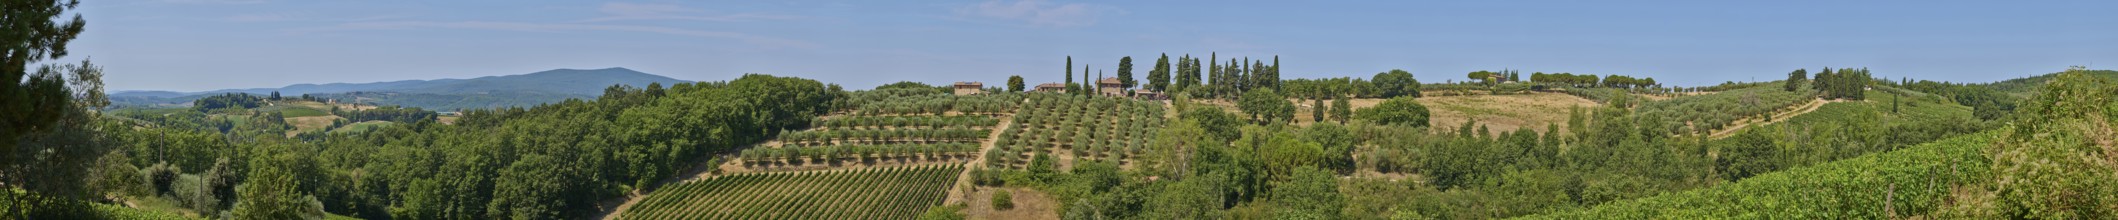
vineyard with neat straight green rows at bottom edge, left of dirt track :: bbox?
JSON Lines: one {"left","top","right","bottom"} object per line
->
{"left": 621, "top": 165, "right": 964, "bottom": 220}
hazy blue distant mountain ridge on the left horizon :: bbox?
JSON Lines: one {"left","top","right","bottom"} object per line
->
{"left": 110, "top": 68, "right": 690, "bottom": 97}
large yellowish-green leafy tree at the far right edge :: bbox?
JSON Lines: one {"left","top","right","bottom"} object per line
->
{"left": 1991, "top": 66, "right": 2118, "bottom": 220}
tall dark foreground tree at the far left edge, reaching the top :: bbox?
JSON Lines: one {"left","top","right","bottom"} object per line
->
{"left": 0, "top": 0, "right": 108, "bottom": 204}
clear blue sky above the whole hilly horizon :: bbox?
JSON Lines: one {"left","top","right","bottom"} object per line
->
{"left": 66, "top": 0, "right": 2118, "bottom": 91}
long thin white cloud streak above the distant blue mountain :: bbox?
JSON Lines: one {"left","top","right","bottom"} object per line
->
{"left": 299, "top": 21, "right": 818, "bottom": 49}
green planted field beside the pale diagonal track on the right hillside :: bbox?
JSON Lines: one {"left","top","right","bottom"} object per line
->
{"left": 1639, "top": 87, "right": 1817, "bottom": 133}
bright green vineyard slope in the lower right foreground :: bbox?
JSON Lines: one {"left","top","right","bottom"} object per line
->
{"left": 1533, "top": 131, "right": 1997, "bottom": 220}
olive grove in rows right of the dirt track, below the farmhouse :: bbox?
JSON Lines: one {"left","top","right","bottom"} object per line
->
{"left": 985, "top": 93, "right": 1165, "bottom": 167}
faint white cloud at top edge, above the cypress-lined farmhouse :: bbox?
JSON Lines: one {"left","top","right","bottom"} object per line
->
{"left": 955, "top": 0, "right": 1116, "bottom": 28}
